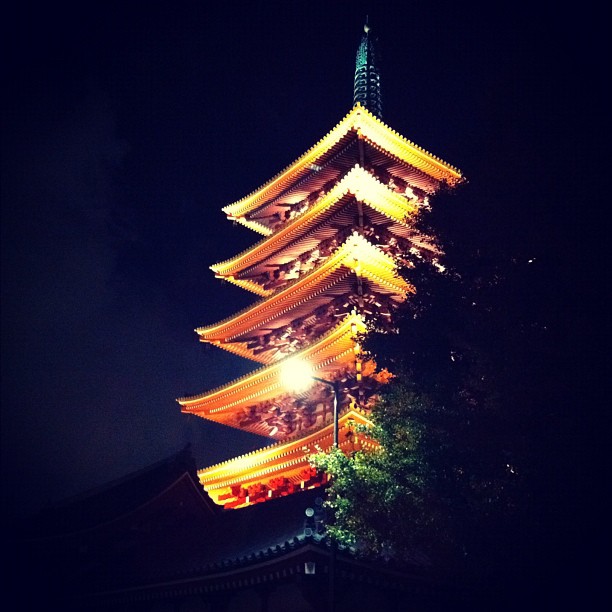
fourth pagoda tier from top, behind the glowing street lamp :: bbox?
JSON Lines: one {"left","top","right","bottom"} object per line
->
{"left": 178, "top": 314, "right": 386, "bottom": 440}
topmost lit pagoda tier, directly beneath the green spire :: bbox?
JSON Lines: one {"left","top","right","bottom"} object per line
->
{"left": 223, "top": 103, "right": 463, "bottom": 235}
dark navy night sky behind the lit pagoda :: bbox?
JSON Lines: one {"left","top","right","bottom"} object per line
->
{"left": 2, "top": 0, "right": 604, "bottom": 510}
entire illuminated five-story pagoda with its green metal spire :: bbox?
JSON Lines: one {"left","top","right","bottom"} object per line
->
{"left": 177, "top": 25, "right": 463, "bottom": 508}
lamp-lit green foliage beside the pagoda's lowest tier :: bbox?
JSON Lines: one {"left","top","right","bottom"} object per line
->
{"left": 313, "top": 389, "right": 436, "bottom": 557}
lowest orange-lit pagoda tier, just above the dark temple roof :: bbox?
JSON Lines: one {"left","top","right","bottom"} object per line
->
{"left": 198, "top": 409, "right": 373, "bottom": 509}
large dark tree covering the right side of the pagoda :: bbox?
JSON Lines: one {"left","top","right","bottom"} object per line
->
{"left": 315, "top": 185, "right": 567, "bottom": 590}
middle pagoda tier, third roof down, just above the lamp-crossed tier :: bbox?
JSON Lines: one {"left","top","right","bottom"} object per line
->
{"left": 196, "top": 233, "right": 414, "bottom": 363}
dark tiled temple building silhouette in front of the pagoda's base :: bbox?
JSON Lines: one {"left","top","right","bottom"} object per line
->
{"left": 10, "top": 448, "right": 466, "bottom": 612}
